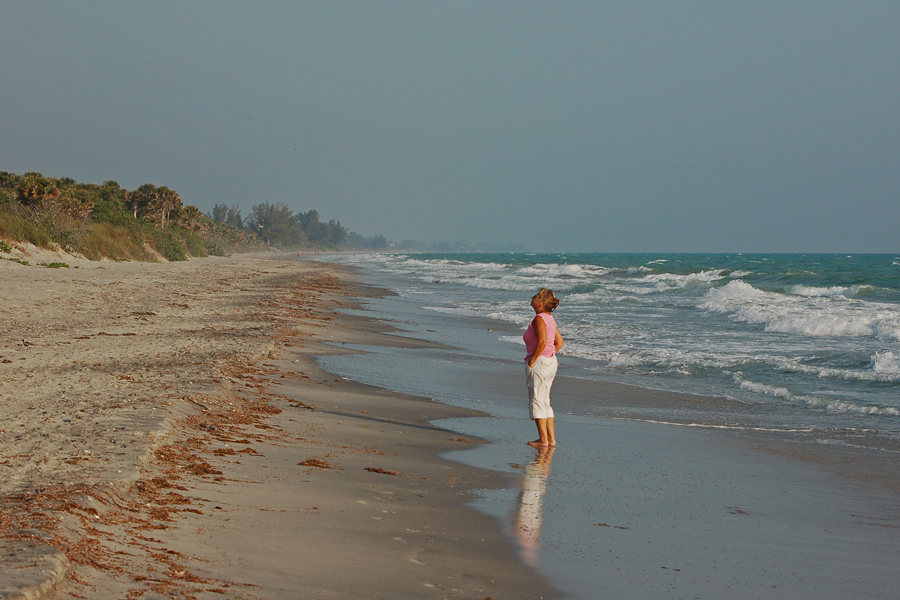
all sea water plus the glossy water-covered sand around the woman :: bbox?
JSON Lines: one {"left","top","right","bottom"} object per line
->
{"left": 320, "top": 253, "right": 900, "bottom": 600}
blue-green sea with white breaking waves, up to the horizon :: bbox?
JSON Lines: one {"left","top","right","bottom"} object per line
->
{"left": 320, "top": 254, "right": 900, "bottom": 448}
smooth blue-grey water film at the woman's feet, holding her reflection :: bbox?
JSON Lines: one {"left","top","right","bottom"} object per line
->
{"left": 440, "top": 415, "right": 900, "bottom": 600}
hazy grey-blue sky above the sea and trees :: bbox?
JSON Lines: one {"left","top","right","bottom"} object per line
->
{"left": 0, "top": 0, "right": 900, "bottom": 252}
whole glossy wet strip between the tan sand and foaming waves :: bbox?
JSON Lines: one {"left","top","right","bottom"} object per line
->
{"left": 308, "top": 268, "right": 900, "bottom": 600}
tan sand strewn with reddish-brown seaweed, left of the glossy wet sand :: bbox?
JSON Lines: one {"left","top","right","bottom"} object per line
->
{"left": 0, "top": 255, "right": 556, "bottom": 599}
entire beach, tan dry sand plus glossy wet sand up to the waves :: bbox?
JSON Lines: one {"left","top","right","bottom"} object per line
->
{"left": 7, "top": 254, "right": 900, "bottom": 600}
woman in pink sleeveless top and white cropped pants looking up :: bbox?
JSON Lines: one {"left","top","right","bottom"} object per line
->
{"left": 523, "top": 288, "right": 563, "bottom": 448}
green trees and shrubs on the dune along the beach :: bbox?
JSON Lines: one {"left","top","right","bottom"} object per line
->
{"left": 0, "top": 171, "right": 389, "bottom": 260}
